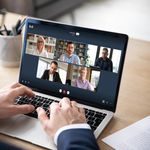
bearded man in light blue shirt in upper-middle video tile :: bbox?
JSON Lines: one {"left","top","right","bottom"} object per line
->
{"left": 60, "top": 42, "right": 80, "bottom": 65}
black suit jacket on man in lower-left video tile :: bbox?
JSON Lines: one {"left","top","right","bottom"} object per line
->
{"left": 41, "top": 70, "right": 62, "bottom": 83}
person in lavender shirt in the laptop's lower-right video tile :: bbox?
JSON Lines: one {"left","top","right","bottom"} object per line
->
{"left": 74, "top": 68, "right": 94, "bottom": 91}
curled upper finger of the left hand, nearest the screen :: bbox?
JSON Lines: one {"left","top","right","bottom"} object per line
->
{"left": 9, "top": 86, "right": 35, "bottom": 100}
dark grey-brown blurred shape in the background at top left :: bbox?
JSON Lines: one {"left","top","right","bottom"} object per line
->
{"left": 0, "top": 0, "right": 87, "bottom": 20}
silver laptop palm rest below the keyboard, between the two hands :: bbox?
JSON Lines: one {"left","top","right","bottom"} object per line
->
{"left": 0, "top": 115, "right": 56, "bottom": 149}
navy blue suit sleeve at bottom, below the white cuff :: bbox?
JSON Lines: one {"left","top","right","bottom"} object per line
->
{"left": 57, "top": 129, "right": 99, "bottom": 150}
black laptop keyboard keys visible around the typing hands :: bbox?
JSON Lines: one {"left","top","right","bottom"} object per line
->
{"left": 16, "top": 95, "right": 106, "bottom": 131}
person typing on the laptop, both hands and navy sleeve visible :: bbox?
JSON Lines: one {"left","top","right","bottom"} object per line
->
{"left": 0, "top": 83, "right": 99, "bottom": 150}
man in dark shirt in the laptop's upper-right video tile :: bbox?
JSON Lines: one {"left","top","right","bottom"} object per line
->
{"left": 95, "top": 48, "right": 113, "bottom": 72}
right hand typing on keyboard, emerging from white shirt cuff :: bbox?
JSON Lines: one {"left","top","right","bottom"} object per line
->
{"left": 37, "top": 98, "right": 86, "bottom": 138}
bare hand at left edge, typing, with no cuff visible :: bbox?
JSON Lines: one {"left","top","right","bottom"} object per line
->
{"left": 0, "top": 83, "right": 35, "bottom": 119}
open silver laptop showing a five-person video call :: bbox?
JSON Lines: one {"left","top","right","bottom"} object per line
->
{"left": 0, "top": 17, "right": 128, "bottom": 149}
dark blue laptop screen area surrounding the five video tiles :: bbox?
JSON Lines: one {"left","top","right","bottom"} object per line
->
{"left": 19, "top": 19, "right": 128, "bottom": 111}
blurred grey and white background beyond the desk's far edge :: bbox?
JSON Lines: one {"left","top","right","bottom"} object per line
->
{"left": 0, "top": 0, "right": 150, "bottom": 41}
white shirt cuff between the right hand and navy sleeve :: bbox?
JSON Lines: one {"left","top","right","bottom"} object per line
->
{"left": 54, "top": 123, "right": 91, "bottom": 145}
